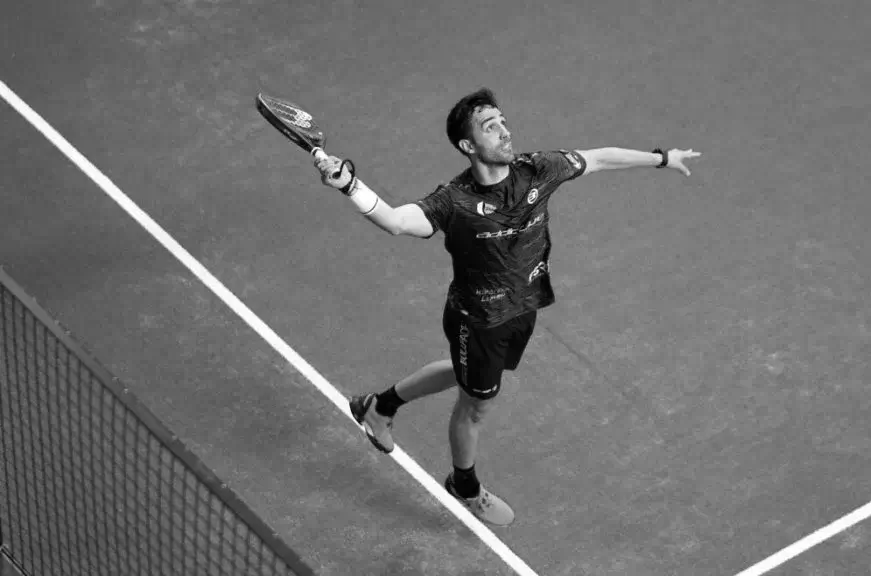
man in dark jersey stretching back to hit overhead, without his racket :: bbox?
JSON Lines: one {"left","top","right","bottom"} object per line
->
{"left": 315, "top": 89, "right": 699, "bottom": 526}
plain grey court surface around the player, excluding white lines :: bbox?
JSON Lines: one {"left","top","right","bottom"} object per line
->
{"left": 0, "top": 0, "right": 871, "bottom": 576}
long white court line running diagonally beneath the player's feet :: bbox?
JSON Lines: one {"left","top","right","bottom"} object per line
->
{"left": 0, "top": 81, "right": 537, "bottom": 576}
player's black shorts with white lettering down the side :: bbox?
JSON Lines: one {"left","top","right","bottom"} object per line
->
{"left": 442, "top": 306, "right": 537, "bottom": 400}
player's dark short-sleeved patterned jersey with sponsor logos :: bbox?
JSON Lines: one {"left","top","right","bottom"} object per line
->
{"left": 417, "top": 150, "right": 586, "bottom": 327}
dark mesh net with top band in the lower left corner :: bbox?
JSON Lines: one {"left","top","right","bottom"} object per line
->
{"left": 0, "top": 269, "right": 313, "bottom": 576}
